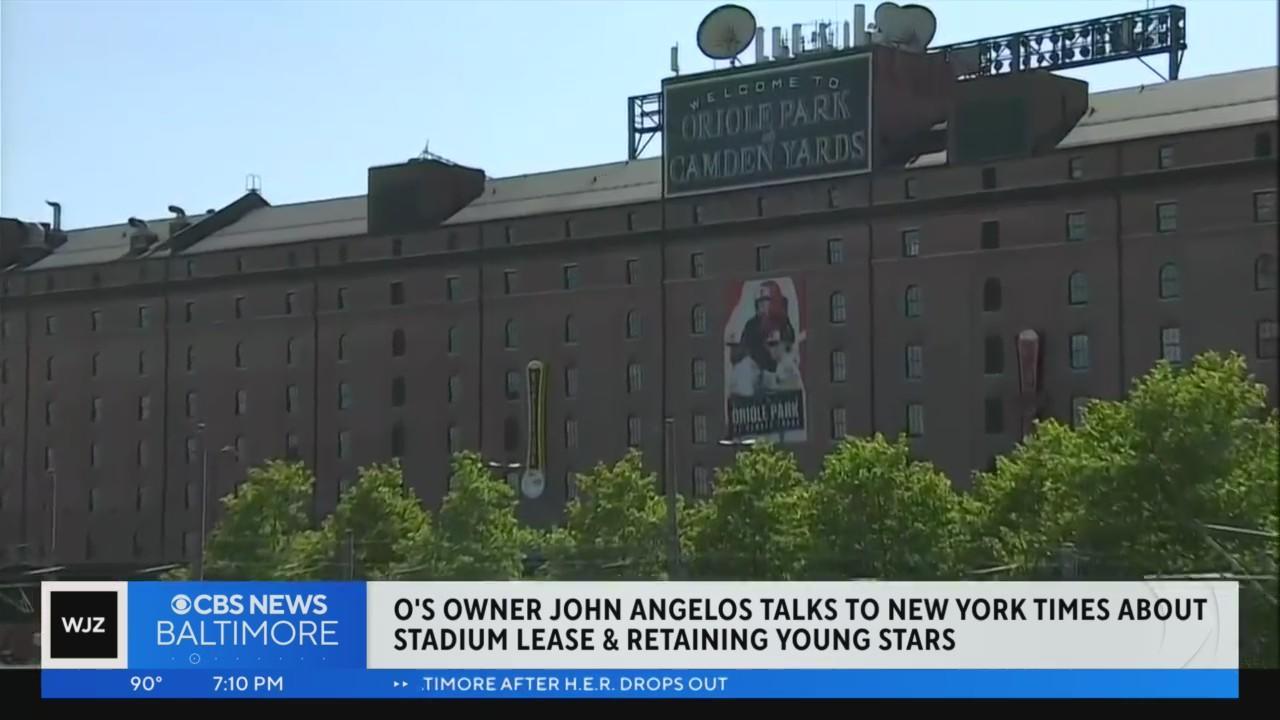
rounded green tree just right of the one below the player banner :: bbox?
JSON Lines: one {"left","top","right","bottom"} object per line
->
{"left": 806, "top": 434, "right": 964, "bottom": 579}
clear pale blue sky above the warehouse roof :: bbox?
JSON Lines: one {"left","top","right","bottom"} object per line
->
{"left": 0, "top": 0, "right": 1276, "bottom": 228}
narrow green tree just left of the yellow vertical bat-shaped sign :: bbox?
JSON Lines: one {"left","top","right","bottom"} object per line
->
{"left": 438, "top": 452, "right": 534, "bottom": 580}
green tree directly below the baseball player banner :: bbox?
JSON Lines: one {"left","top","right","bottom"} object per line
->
{"left": 684, "top": 443, "right": 810, "bottom": 580}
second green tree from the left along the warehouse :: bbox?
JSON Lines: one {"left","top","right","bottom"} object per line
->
{"left": 294, "top": 461, "right": 436, "bottom": 579}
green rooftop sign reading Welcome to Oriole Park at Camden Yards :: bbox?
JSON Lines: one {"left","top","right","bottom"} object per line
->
{"left": 662, "top": 51, "right": 872, "bottom": 196}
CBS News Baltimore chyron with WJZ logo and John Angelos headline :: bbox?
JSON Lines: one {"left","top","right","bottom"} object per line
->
{"left": 41, "top": 582, "right": 1239, "bottom": 700}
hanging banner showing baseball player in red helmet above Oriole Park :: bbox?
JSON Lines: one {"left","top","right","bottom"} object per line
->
{"left": 724, "top": 278, "right": 808, "bottom": 443}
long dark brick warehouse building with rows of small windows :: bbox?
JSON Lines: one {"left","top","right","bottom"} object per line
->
{"left": 0, "top": 49, "right": 1277, "bottom": 562}
